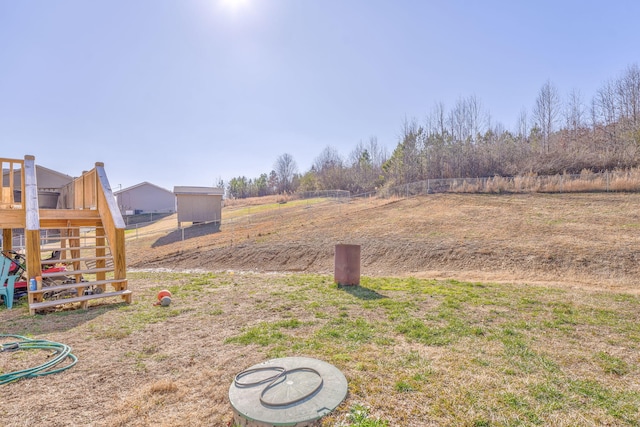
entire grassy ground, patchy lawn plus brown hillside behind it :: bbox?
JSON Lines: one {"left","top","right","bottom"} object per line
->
{"left": 0, "top": 193, "right": 640, "bottom": 427}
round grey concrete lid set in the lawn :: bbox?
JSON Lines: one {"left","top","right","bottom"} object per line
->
{"left": 229, "top": 357, "right": 347, "bottom": 426}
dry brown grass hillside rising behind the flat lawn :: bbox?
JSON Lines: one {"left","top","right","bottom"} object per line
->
{"left": 128, "top": 193, "right": 640, "bottom": 292}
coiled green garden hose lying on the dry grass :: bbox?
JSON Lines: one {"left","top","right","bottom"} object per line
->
{"left": 0, "top": 334, "right": 78, "bottom": 385}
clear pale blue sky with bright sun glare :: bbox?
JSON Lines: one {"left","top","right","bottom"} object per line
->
{"left": 0, "top": 0, "right": 640, "bottom": 191}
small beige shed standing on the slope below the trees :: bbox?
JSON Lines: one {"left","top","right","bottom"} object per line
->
{"left": 173, "top": 187, "right": 224, "bottom": 227}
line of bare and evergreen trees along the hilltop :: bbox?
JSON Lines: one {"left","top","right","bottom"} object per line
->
{"left": 226, "top": 64, "right": 640, "bottom": 198}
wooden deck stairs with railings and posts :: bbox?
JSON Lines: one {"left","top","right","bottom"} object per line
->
{"left": 0, "top": 156, "right": 132, "bottom": 314}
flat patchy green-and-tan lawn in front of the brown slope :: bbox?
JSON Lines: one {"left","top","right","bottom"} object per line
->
{"left": 0, "top": 272, "right": 640, "bottom": 427}
